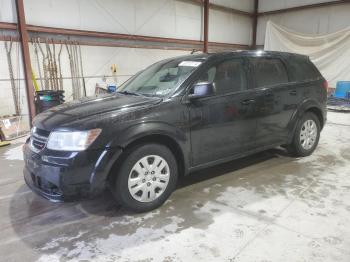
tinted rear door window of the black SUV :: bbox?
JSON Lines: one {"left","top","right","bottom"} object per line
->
{"left": 250, "top": 58, "right": 288, "bottom": 88}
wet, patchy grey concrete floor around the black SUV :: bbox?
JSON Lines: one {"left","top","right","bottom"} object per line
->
{"left": 0, "top": 113, "right": 350, "bottom": 262}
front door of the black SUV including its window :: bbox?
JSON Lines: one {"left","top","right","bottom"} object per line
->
{"left": 189, "top": 58, "right": 256, "bottom": 166}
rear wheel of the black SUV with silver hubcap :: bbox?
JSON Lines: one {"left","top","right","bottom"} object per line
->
{"left": 287, "top": 112, "right": 321, "bottom": 157}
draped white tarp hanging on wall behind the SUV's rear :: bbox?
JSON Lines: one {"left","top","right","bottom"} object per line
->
{"left": 265, "top": 21, "right": 350, "bottom": 87}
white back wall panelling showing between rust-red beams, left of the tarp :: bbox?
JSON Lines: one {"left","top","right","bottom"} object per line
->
{"left": 0, "top": 0, "right": 253, "bottom": 116}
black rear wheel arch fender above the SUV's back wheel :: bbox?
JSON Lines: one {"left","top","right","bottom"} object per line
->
{"left": 288, "top": 98, "right": 325, "bottom": 143}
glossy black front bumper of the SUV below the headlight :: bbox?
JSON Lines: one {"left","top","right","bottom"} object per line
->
{"left": 23, "top": 143, "right": 122, "bottom": 201}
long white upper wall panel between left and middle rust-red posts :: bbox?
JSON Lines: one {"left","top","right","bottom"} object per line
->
{"left": 25, "top": 0, "right": 202, "bottom": 40}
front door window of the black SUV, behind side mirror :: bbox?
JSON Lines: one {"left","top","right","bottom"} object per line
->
{"left": 198, "top": 59, "right": 247, "bottom": 95}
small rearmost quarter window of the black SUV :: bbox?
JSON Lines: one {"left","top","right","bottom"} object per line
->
{"left": 288, "top": 59, "right": 319, "bottom": 81}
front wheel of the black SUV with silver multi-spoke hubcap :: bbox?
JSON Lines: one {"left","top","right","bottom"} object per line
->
{"left": 111, "top": 144, "right": 178, "bottom": 212}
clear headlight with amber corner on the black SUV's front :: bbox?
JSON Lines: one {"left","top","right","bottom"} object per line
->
{"left": 47, "top": 128, "right": 101, "bottom": 151}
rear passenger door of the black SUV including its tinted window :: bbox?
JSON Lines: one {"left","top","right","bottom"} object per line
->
{"left": 249, "top": 57, "right": 298, "bottom": 147}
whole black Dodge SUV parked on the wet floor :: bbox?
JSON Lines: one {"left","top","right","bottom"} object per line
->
{"left": 24, "top": 51, "right": 327, "bottom": 212}
